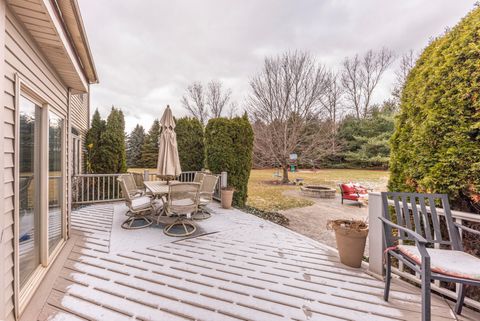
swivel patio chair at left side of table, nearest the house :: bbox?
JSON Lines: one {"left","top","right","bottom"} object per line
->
{"left": 117, "top": 174, "right": 153, "bottom": 229}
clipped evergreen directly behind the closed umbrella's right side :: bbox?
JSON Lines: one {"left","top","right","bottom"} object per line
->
{"left": 175, "top": 117, "right": 205, "bottom": 171}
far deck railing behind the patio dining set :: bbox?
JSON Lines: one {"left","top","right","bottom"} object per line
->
{"left": 72, "top": 170, "right": 227, "bottom": 205}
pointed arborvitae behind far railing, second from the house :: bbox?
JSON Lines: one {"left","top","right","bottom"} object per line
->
{"left": 100, "top": 107, "right": 127, "bottom": 174}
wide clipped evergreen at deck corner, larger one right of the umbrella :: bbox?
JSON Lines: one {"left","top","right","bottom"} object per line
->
{"left": 205, "top": 116, "right": 253, "bottom": 207}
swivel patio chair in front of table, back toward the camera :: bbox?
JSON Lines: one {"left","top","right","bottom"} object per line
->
{"left": 163, "top": 183, "right": 200, "bottom": 237}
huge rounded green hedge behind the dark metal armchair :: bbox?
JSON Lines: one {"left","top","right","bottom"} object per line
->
{"left": 389, "top": 8, "right": 480, "bottom": 212}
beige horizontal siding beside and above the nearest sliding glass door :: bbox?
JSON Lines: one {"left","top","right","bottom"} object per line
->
{"left": 0, "top": 8, "right": 72, "bottom": 320}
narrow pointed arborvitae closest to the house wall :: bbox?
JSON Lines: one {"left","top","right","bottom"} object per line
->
{"left": 85, "top": 109, "right": 106, "bottom": 173}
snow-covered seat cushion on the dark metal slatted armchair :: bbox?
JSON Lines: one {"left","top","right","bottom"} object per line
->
{"left": 397, "top": 245, "right": 480, "bottom": 280}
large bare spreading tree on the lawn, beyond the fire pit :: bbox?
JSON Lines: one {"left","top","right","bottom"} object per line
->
{"left": 247, "top": 52, "right": 326, "bottom": 183}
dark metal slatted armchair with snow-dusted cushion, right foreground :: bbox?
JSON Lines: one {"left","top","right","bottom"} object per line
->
{"left": 379, "top": 192, "right": 480, "bottom": 321}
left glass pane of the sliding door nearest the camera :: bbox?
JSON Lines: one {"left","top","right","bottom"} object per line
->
{"left": 19, "top": 97, "right": 41, "bottom": 286}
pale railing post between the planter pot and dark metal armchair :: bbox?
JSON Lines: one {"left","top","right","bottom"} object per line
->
{"left": 368, "top": 193, "right": 385, "bottom": 275}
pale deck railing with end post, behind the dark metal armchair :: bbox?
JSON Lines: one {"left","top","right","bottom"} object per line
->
{"left": 368, "top": 193, "right": 480, "bottom": 309}
